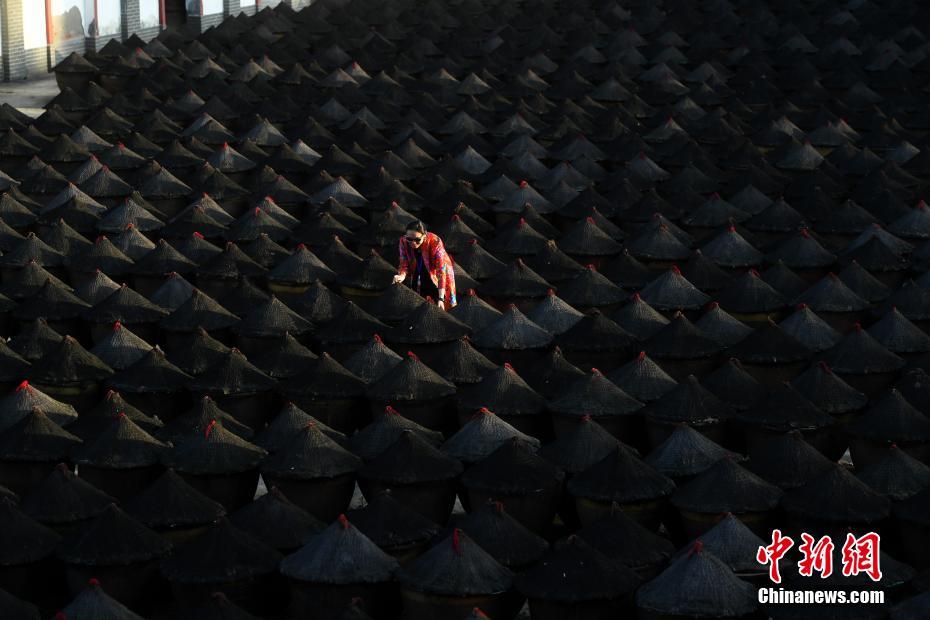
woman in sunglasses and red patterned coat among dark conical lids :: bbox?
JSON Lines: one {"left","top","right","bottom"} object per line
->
{"left": 394, "top": 220, "right": 456, "bottom": 310}
